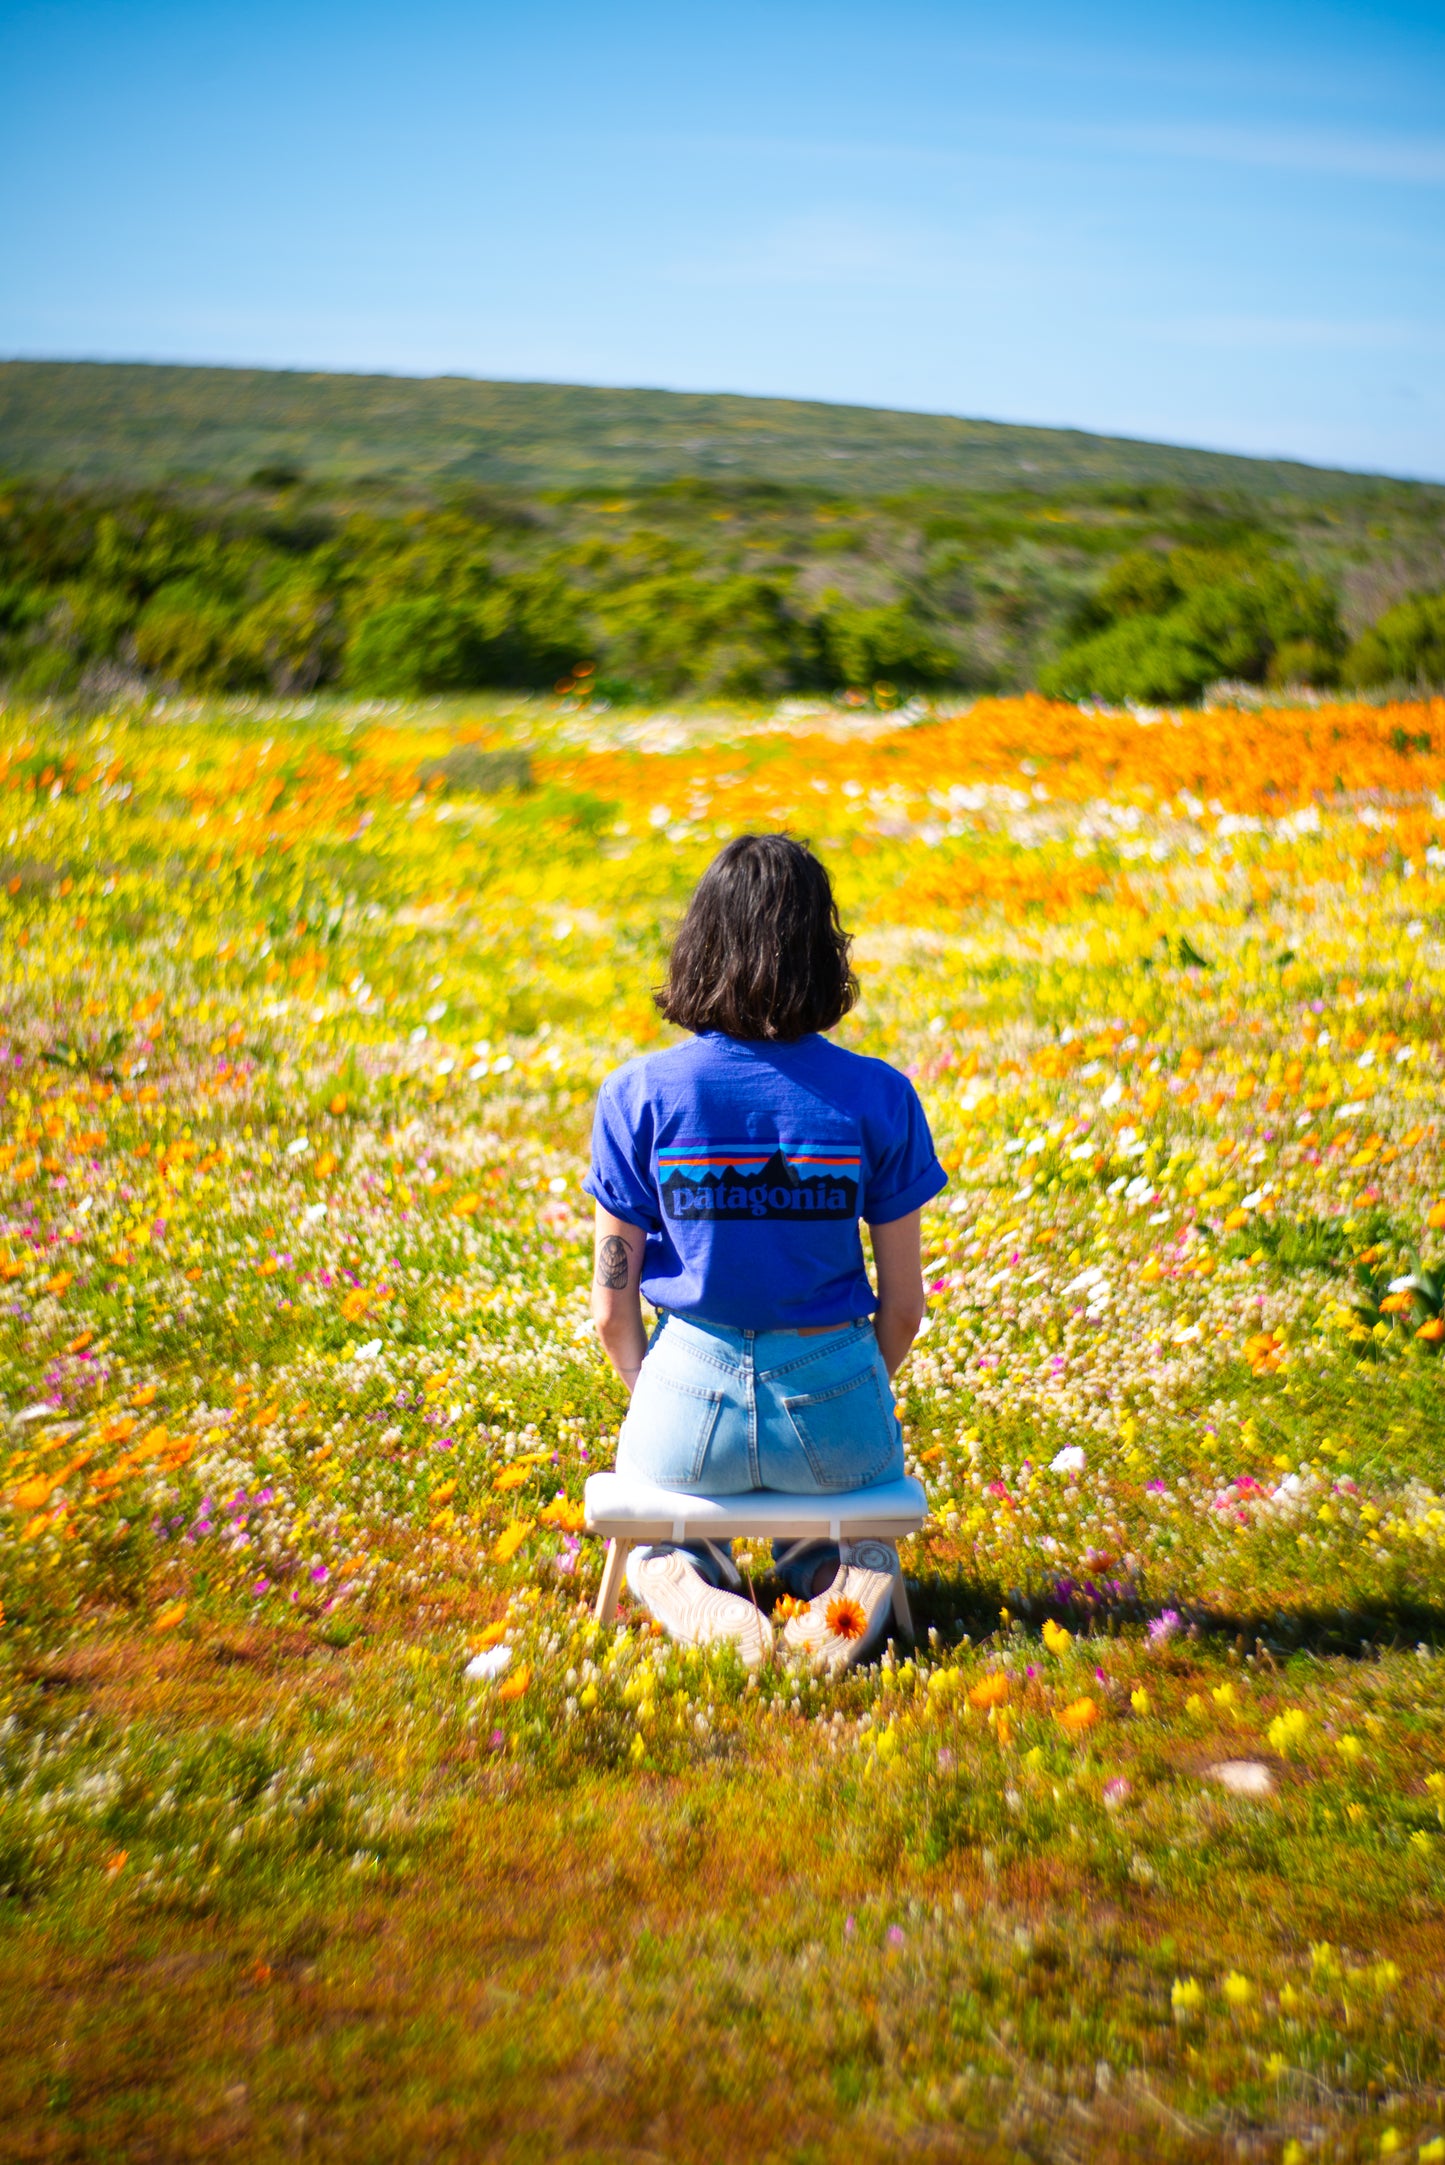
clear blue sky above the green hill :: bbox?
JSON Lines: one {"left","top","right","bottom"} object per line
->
{"left": 0, "top": 0, "right": 1445, "bottom": 478}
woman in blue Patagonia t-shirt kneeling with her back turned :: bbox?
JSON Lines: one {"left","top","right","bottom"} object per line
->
{"left": 585, "top": 834, "right": 945, "bottom": 1665}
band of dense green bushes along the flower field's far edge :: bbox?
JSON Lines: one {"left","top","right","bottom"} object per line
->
{"left": 0, "top": 468, "right": 1445, "bottom": 701}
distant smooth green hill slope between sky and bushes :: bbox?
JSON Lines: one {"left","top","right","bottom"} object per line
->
{"left": 0, "top": 362, "right": 1445, "bottom": 502}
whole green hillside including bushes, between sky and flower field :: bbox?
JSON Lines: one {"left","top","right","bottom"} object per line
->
{"left": 0, "top": 362, "right": 1445, "bottom": 704}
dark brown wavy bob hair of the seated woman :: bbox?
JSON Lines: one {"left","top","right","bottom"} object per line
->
{"left": 654, "top": 834, "right": 858, "bottom": 1044}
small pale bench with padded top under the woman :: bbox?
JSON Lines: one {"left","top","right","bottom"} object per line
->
{"left": 583, "top": 1474, "right": 927, "bottom": 1639}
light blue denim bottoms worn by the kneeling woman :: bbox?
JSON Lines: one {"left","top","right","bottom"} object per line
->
{"left": 617, "top": 1316, "right": 903, "bottom": 1496}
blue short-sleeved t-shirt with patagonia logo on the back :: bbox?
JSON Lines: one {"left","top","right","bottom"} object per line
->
{"left": 583, "top": 1031, "right": 947, "bottom": 1331}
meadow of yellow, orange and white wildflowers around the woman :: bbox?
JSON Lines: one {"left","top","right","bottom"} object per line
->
{"left": 0, "top": 684, "right": 1445, "bottom": 2165}
